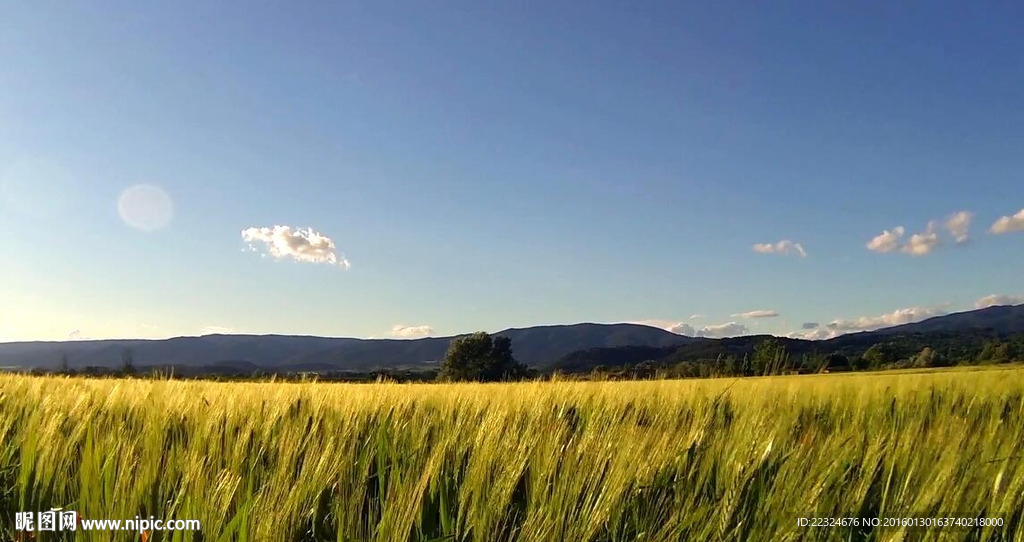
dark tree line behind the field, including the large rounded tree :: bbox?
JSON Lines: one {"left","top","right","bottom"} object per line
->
{"left": 22, "top": 331, "right": 1024, "bottom": 382}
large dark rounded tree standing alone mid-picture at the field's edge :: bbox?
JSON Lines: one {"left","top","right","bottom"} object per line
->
{"left": 438, "top": 331, "right": 526, "bottom": 382}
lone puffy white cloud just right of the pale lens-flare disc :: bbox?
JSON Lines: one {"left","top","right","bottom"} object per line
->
{"left": 242, "top": 225, "right": 351, "bottom": 269}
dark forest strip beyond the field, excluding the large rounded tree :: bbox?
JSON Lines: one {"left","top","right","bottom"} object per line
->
{"left": 22, "top": 330, "right": 1024, "bottom": 382}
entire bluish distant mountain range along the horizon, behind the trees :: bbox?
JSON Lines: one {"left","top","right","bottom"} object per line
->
{"left": 0, "top": 305, "right": 1024, "bottom": 372}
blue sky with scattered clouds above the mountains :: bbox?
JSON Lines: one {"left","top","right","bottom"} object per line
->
{"left": 0, "top": 2, "right": 1024, "bottom": 340}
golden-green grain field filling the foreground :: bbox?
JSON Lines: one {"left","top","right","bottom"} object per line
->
{"left": 0, "top": 368, "right": 1024, "bottom": 542}
